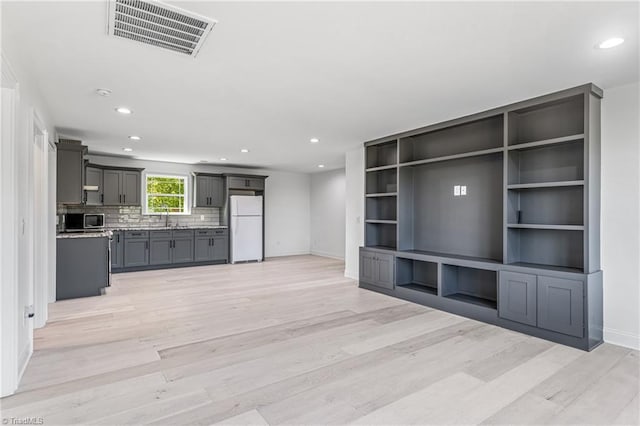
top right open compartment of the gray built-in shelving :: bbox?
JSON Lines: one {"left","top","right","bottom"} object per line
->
{"left": 509, "top": 94, "right": 584, "bottom": 145}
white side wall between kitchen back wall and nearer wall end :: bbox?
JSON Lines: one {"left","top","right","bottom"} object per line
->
{"left": 311, "top": 169, "right": 345, "bottom": 259}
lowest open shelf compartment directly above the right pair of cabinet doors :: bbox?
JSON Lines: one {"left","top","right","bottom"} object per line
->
{"left": 507, "top": 228, "right": 584, "bottom": 272}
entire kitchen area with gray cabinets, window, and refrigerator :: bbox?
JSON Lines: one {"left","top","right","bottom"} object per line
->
{"left": 56, "top": 139, "right": 267, "bottom": 300}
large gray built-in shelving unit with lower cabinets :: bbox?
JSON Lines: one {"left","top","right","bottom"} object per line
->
{"left": 360, "top": 84, "right": 602, "bottom": 350}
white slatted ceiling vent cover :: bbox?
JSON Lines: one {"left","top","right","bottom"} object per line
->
{"left": 108, "top": 0, "right": 217, "bottom": 57}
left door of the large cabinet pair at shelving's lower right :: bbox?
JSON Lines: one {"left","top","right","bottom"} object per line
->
{"left": 498, "top": 271, "right": 538, "bottom": 326}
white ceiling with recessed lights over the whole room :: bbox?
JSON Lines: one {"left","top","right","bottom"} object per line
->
{"left": 2, "top": 1, "right": 639, "bottom": 172}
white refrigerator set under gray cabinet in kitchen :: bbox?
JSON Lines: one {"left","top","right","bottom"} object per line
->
{"left": 230, "top": 195, "right": 263, "bottom": 263}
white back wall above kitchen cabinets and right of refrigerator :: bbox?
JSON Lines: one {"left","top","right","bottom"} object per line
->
{"left": 87, "top": 156, "right": 310, "bottom": 257}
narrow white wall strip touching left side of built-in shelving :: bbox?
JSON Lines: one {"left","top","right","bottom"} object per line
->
{"left": 344, "top": 146, "right": 364, "bottom": 280}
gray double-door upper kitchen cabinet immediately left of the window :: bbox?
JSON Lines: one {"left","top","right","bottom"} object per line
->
{"left": 103, "top": 168, "right": 143, "bottom": 206}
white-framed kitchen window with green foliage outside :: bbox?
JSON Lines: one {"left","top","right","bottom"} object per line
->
{"left": 145, "top": 174, "right": 189, "bottom": 214}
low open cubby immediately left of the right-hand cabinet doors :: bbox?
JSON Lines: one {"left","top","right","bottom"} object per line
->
{"left": 442, "top": 264, "right": 498, "bottom": 309}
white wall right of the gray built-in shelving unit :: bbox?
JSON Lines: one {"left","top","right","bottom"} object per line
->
{"left": 601, "top": 83, "right": 640, "bottom": 349}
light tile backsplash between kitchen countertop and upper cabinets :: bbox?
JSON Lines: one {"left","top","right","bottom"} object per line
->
{"left": 57, "top": 204, "right": 224, "bottom": 229}
